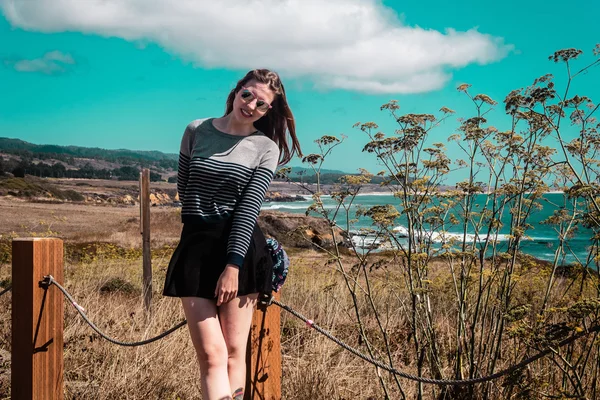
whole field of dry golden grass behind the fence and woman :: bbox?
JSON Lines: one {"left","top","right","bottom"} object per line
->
{"left": 0, "top": 197, "right": 598, "bottom": 400}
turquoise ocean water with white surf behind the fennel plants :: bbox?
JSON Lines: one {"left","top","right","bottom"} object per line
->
{"left": 262, "top": 193, "right": 593, "bottom": 266}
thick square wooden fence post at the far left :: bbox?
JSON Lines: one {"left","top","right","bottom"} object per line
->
{"left": 10, "top": 238, "right": 64, "bottom": 400}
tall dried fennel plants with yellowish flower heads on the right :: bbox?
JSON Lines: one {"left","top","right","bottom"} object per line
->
{"left": 278, "top": 46, "right": 600, "bottom": 399}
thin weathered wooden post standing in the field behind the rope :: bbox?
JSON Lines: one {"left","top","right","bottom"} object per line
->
{"left": 140, "top": 168, "right": 152, "bottom": 317}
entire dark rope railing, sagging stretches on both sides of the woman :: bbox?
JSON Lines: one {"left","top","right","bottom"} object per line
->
{"left": 41, "top": 275, "right": 600, "bottom": 386}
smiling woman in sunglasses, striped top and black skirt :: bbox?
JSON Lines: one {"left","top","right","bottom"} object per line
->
{"left": 163, "top": 69, "right": 301, "bottom": 400}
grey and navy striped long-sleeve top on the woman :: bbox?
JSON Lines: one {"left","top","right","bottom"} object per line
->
{"left": 177, "top": 118, "right": 279, "bottom": 267}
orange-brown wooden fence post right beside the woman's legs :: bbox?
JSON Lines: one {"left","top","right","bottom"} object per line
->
{"left": 244, "top": 291, "right": 281, "bottom": 400}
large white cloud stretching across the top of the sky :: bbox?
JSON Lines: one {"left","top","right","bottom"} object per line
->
{"left": 0, "top": 0, "right": 511, "bottom": 93}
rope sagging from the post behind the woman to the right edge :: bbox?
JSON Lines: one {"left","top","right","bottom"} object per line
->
{"left": 271, "top": 299, "right": 600, "bottom": 386}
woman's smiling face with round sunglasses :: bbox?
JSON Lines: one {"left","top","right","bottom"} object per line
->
{"left": 232, "top": 80, "right": 275, "bottom": 124}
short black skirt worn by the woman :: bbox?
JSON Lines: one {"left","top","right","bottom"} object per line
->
{"left": 163, "top": 219, "right": 273, "bottom": 299}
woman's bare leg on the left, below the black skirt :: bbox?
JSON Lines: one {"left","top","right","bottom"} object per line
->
{"left": 181, "top": 297, "right": 235, "bottom": 400}
